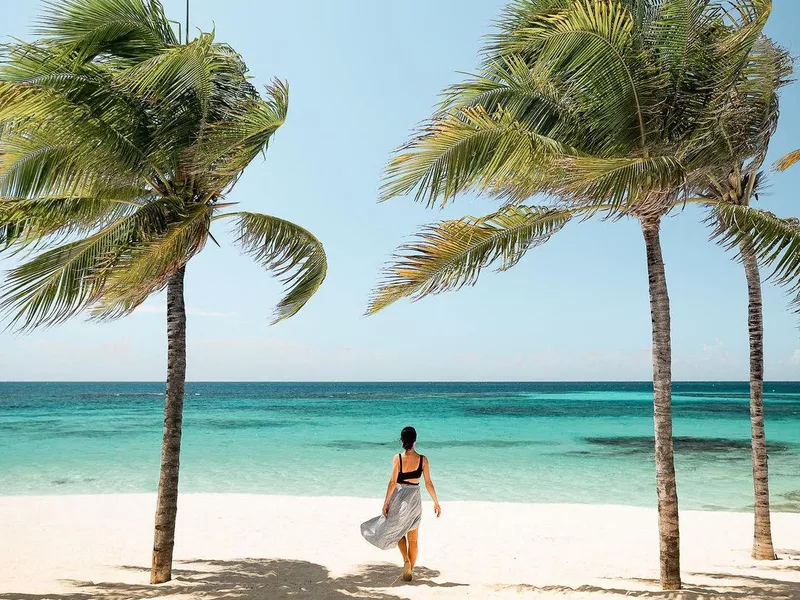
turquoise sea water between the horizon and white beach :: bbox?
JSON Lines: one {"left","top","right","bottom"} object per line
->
{"left": 0, "top": 382, "right": 800, "bottom": 511}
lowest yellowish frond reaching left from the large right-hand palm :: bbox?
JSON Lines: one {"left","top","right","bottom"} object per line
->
{"left": 367, "top": 205, "right": 574, "bottom": 314}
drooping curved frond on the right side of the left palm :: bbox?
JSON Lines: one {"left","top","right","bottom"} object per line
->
{"left": 223, "top": 212, "right": 328, "bottom": 324}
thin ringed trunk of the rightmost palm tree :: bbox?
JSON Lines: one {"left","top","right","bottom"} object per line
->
{"left": 739, "top": 239, "right": 777, "bottom": 560}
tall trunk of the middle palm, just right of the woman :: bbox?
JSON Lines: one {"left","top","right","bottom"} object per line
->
{"left": 642, "top": 218, "right": 681, "bottom": 590}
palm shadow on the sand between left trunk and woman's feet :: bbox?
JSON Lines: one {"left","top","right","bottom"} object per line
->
{"left": 0, "top": 559, "right": 465, "bottom": 600}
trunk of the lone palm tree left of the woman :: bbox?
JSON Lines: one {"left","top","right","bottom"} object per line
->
{"left": 150, "top": 267, "right": 186, "bottom": 583}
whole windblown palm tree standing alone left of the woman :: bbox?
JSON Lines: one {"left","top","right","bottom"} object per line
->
{"left": 0, "top": 0, "right": 327, "bottom": 583}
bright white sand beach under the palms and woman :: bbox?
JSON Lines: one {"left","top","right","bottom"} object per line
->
{"left": 0, "top": 494, "right": 800, "bottom": 600}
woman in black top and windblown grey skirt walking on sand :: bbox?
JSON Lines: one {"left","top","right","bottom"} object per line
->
{"left": 361, "top": 427, "right": 442, "bottom": 581}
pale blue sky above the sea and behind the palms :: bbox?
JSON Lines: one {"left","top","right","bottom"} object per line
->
{"left": 0, "top": 0, "right": 800, "bottom": 381}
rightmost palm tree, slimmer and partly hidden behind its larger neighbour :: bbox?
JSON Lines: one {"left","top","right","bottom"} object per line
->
{"left": 688, "top": 37, "right": 796, "bottom": 560}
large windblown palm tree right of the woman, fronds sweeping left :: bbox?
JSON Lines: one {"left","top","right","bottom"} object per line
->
{"left": 368, "top": 0, "right": 788, "bottom": 589}
